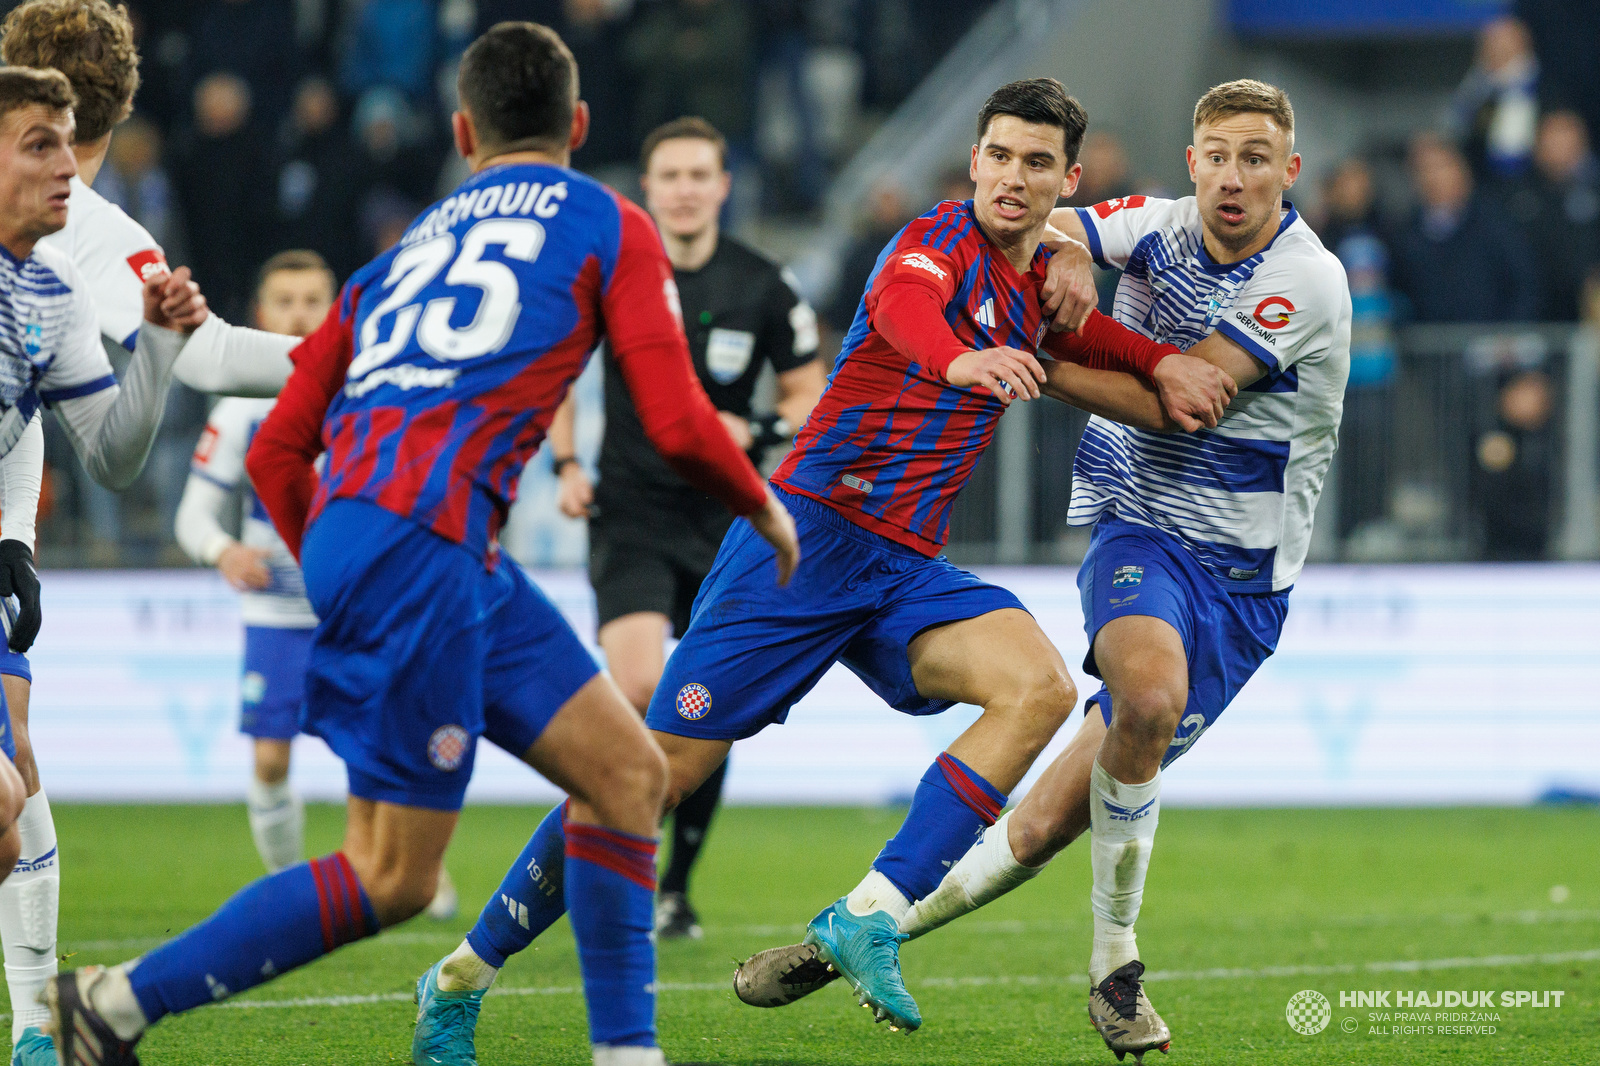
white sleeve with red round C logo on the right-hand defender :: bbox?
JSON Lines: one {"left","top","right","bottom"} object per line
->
{"left": 1216, "top": 250, "right": 1350, "bottom": 378}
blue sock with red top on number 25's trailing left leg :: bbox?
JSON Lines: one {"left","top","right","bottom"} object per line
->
{"left": 128, "top": 852, "right": 378, "bottom": 1024}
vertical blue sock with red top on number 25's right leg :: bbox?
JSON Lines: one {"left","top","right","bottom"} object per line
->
{"left": 566, "top": 823, "right": 656, "bottom": 1047}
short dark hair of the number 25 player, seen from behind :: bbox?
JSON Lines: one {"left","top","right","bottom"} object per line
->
{"left": 456, "top": 22, "right": 578, "bottom": 152}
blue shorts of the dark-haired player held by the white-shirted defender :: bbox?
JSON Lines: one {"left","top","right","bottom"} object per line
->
{"left": 645, "top": 490, "right": 1022, "bottom": 739}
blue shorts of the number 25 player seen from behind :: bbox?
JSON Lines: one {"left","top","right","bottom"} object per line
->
{"left": 301, "top": 499, "right": 600, "bottom": 810}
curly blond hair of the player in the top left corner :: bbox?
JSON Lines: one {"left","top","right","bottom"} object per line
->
{"left": 0, "top": 0, "right": 139, "bottom": 142}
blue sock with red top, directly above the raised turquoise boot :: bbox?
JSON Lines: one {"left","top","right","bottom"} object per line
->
{"left": 872, "top": 752, "right": 1005, "bottom": 903}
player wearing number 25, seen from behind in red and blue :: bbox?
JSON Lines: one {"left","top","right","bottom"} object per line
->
{"left": 50, "top": 22, "right": 798, "bottom": 1066}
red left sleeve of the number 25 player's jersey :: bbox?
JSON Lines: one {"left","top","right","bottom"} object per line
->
{"left": 245, "top": 287, "right": 360, "bottom": 559}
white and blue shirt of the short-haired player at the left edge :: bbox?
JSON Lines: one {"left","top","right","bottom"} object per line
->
{"left": 0, "top": 245, "right": 117, "bottom": 455}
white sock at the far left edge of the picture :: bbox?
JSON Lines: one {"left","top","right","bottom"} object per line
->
{"left": 0, "top": 789, "right": 61, "bottom": 1044}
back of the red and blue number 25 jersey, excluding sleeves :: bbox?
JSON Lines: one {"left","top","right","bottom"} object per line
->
{"left": 320, "top": 165, "right": 636, "bottom": 547}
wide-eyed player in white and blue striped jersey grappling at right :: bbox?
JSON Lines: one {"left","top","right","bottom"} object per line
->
{"left": 734, "top": 80, "right": 1350, "bottom": 1058}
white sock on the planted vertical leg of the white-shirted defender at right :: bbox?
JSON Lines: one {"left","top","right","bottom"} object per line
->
{"left": 1090, "top": 759, "right": 1162, "bottom": 984}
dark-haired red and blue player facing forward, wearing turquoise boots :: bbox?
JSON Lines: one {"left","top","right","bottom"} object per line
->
{"left": 371, "top": 80, "right": 1224, "bottom": 1045}
